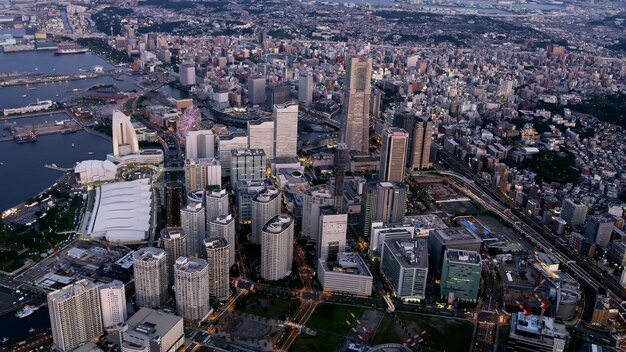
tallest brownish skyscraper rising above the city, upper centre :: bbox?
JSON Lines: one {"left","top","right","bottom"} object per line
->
{"left": 341, "top": 56, "right": 372, "bottom": 152}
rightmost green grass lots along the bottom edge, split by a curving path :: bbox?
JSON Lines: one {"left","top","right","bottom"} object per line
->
{"left": 372, "top": 313, "right": 474, "bottom": 351}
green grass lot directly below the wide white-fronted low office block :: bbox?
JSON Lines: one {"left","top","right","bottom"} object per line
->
{"left": 305, "top": 303, "right": 363, "bottom": 336}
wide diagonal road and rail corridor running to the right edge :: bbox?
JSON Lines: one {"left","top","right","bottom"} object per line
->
{"left": 439, "top": 149, "right": 626, "bottom": 309}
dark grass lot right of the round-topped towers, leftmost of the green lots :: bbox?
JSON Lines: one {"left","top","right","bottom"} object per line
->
{"left": 236, "top": 293, "right": 300, "bottom": 320}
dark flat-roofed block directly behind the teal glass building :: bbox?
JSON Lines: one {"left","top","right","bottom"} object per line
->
{"left": 428, "top": 227, "right": 483, "bottom": 277}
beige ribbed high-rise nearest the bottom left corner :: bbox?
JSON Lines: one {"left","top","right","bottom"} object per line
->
{"left": 48, "top": 279, "right": 104, "bottom": 351}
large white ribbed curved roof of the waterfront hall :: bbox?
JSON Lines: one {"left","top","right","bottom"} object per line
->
{"left": 87, "top": 178, "right": 152, "bottom": 242}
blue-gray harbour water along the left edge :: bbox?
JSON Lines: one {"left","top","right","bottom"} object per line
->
{"left": 0, "top": 51, "right": 120, "bottom": 210}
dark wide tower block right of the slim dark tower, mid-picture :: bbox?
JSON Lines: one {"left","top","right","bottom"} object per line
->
{"left": 361, "top": 182, "right": 408, "bottom": 237}
